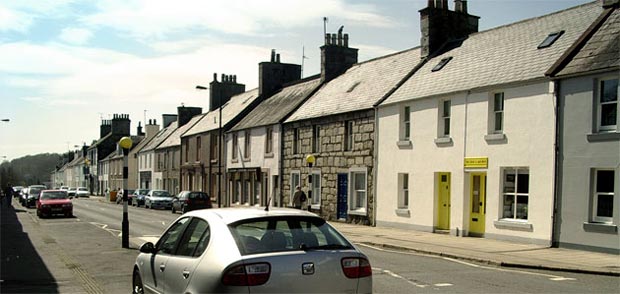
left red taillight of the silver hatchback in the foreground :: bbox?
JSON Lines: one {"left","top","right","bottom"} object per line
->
{"left": 222, "top": 263, "right": 271, "bottom": 286}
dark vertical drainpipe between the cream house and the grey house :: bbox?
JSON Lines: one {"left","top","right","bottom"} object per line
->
{"left": 551, "top": 80, "right": 562, "bottom": 248}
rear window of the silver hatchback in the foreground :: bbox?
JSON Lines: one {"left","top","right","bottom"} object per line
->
{"left": 228, "top": 216, "right": 353, "bottom": 255}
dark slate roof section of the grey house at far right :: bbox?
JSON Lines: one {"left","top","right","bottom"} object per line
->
{"left": 556, "top": 9, "right": 620, "bottom": 76}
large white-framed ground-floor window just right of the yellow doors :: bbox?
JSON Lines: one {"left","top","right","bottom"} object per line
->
{"left": 501, "top": 167, "right": 531, "bottom": 222}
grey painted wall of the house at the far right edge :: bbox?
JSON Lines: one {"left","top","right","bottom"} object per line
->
{"left": 558, "top": 72, "right": 620, "bottom": 254}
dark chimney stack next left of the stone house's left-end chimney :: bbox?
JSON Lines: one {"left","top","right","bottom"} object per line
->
{"left": 258, "top": 49, "right": 301, "bottom": 96}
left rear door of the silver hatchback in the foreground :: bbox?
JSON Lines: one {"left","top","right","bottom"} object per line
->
{"left": 164, "top": 217, "right": 211, "bottom": 293}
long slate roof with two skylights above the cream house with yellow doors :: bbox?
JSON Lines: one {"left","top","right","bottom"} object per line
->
{"left": 382, "top": 2, "right": 603, "bottom": 105}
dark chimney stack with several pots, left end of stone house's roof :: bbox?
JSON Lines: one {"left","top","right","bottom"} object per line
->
{"left": 321, "top": 26, "right": 358, "bottom": 82}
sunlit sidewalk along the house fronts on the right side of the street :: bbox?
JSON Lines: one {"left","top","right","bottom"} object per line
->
{"left": 330, "top": 222, "right": 620, "bottom": 276}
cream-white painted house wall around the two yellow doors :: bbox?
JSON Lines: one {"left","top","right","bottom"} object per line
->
{"left": 377, "top": 82, "right": 555, "bottom": 244}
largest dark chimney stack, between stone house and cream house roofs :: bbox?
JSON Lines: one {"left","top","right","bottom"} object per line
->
{"left": 420, "top": 0, "right": 480, "bottom": 58}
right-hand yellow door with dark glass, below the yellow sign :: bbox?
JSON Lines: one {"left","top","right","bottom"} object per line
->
{"left": 469, "top": 173, "right": 486, "bottom": 236}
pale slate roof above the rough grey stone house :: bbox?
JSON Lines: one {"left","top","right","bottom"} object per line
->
{"left": 286, "top": 47, "right": 420, "bottom": 122}
